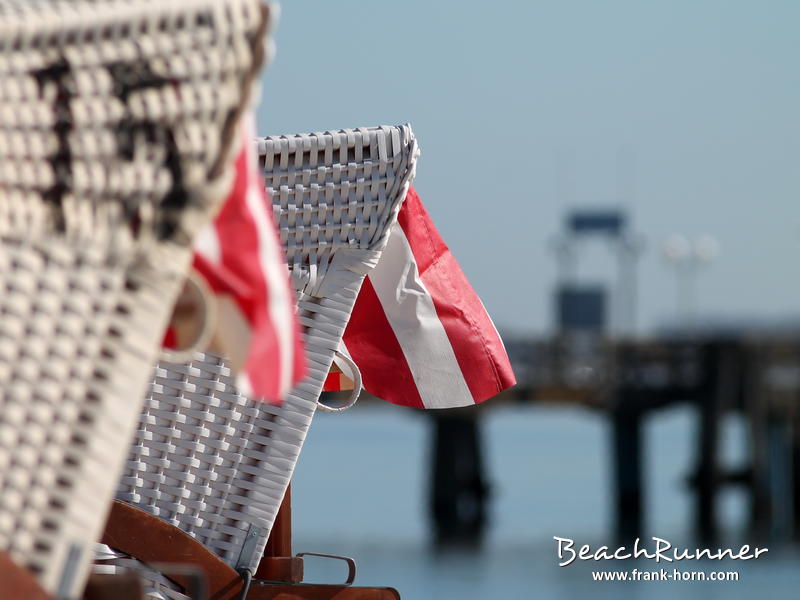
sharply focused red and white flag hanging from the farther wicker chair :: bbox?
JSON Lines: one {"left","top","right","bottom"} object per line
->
{"left": 336, "top": 188, "right": 516, "bottom": 408}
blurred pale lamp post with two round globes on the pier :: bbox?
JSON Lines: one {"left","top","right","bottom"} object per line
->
{"left": 663, "top": 234, "right": 719, "bottom": 329}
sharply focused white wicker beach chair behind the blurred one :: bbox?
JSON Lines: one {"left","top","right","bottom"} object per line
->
{"left": 107, "top": 126, "right": 418, "bottom": 598}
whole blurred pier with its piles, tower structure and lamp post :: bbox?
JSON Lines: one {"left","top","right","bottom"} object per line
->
{"left": 429, "top": 207, "right": 800, "bottom": 544}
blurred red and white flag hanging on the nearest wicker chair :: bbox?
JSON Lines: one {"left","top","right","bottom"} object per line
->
{"left": 194, "top": 119, "right": 305, "bottom": 402}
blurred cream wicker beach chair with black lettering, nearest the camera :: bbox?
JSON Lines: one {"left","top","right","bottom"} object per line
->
{"left": 0, "top": 0, "right": 267, "bottom": 597}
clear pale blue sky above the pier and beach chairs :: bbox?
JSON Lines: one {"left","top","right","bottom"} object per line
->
{"left": 259, "top": 0, "right": 800, "bottom": 332}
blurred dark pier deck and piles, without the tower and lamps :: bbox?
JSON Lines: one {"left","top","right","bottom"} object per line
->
{"left": 430, "top": 335, "right": 800, "bottom": 543}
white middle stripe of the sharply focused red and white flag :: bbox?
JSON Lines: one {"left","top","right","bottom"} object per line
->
{"left": 370, "top": 224, "right": 472, "bottom": 408}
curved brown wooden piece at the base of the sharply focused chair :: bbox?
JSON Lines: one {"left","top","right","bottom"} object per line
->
{"left": 102, "top": 500, "right": 242, "bottom": 600}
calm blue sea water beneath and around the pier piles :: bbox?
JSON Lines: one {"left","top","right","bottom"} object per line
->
{"left": 294, "top": 405, "right": 800, "bottom": 600}
